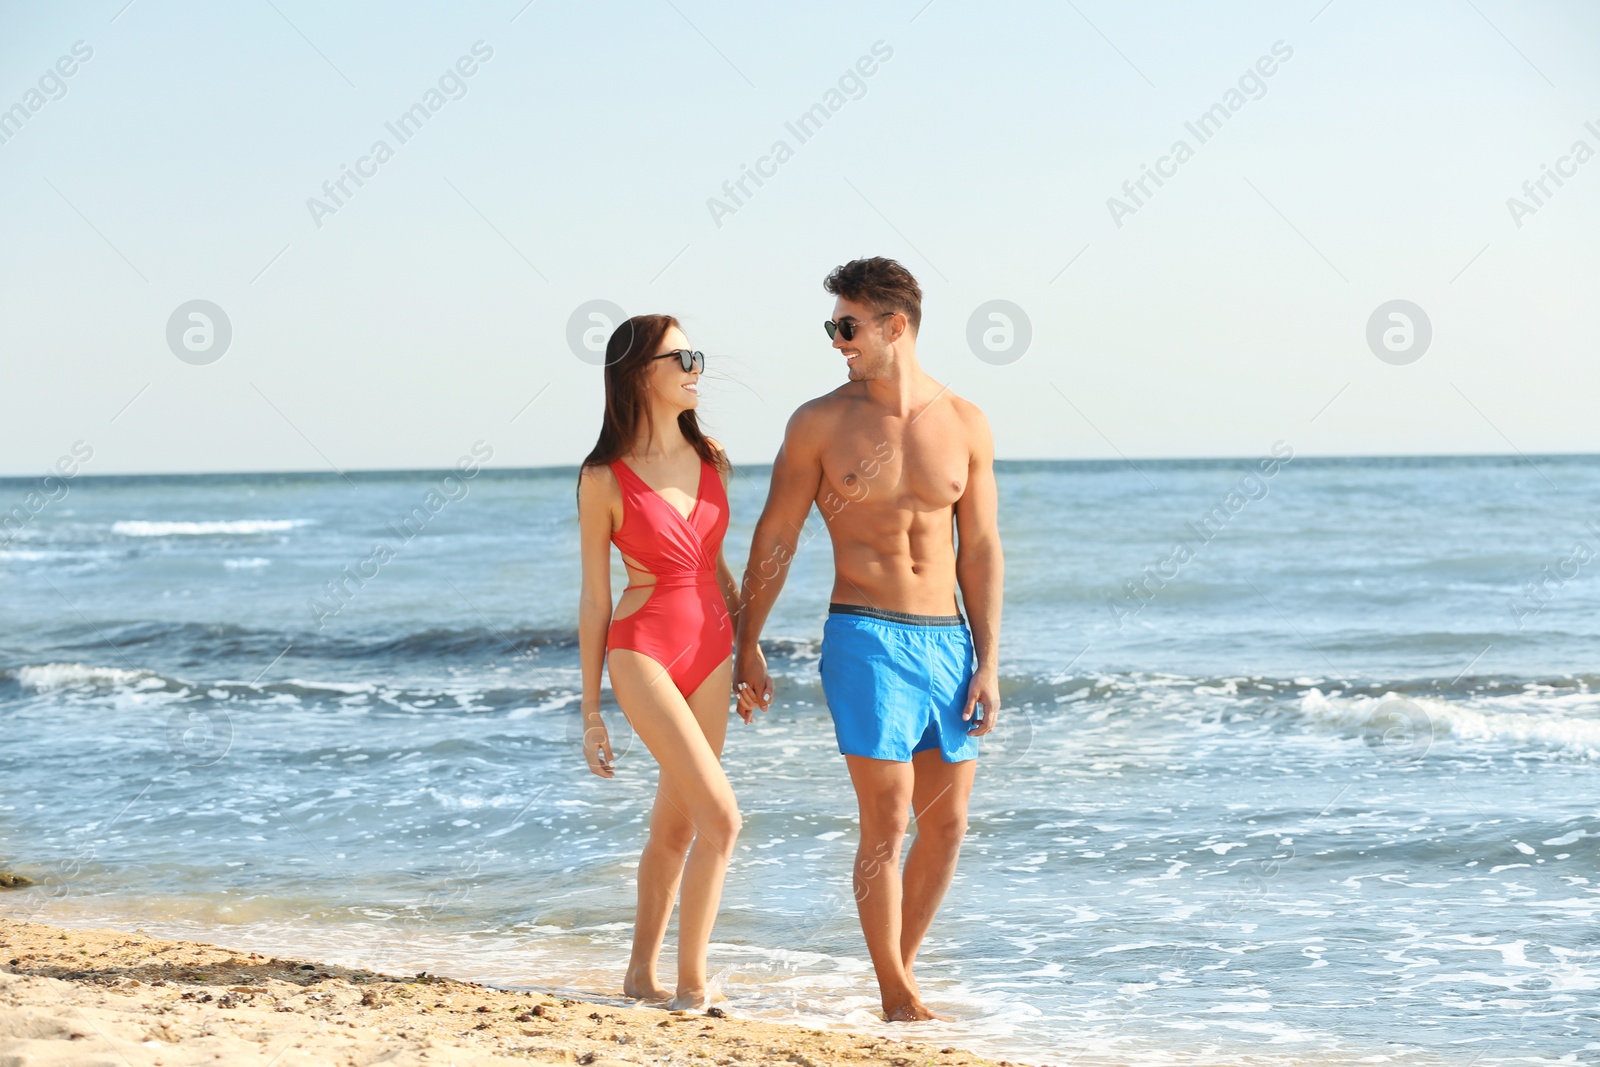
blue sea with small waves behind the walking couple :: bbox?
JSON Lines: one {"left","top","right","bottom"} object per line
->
{"left": 0, "top": 458, "right": 1600, "bottom": 1064}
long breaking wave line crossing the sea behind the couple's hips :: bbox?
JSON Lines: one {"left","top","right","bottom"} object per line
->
{"left": 18, "top": 622, "right": 1600, "bottom": 760}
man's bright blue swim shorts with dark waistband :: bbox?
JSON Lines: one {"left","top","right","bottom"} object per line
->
{"left": 819, "top": 603, "right": 978, "bottom": 763}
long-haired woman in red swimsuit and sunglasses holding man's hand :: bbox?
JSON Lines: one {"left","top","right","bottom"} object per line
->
{"left": 578, "top": 315, "right": 739, "bottom": 1009}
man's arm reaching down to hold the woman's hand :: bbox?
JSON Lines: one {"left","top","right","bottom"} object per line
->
{"left": 733, "top": 402, "right": 822, "bottom": 721}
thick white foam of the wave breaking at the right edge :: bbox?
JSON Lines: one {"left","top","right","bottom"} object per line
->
{"left": 1299, "top": 688, "right": 1600, "bottom": 760}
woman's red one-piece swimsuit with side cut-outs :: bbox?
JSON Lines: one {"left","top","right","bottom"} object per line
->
{"left": 606, "top": 459, "right": 733, "bottom": 697}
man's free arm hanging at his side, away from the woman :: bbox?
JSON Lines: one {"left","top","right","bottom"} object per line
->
{"left": 955, "top": 405, "right": 1005, "bottom": 734}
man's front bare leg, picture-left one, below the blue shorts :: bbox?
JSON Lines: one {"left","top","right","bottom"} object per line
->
{"left": 845, "top": 755, "right": 939, "bottom": 1022}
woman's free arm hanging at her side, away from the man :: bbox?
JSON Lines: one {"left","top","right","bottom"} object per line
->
{"left": 578, "top": 467, "right": 621, "bottom": 777}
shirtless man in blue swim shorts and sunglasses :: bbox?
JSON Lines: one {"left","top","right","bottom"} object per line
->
{"left": 734, "top": 258, "right": 1003, "bottom": 1022}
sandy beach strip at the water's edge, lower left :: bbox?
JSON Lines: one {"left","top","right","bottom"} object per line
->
{"left": 0, "top": 918, "right": 1006, "bottom": 1067}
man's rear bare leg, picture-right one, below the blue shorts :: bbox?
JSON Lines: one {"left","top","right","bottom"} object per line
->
{"left": 899, "top": 749, "right": 978, "bottom": 992}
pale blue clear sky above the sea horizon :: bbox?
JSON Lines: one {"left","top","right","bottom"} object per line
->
{"left": 0, "top": 0, "right": 1600, "bottom": 475}
